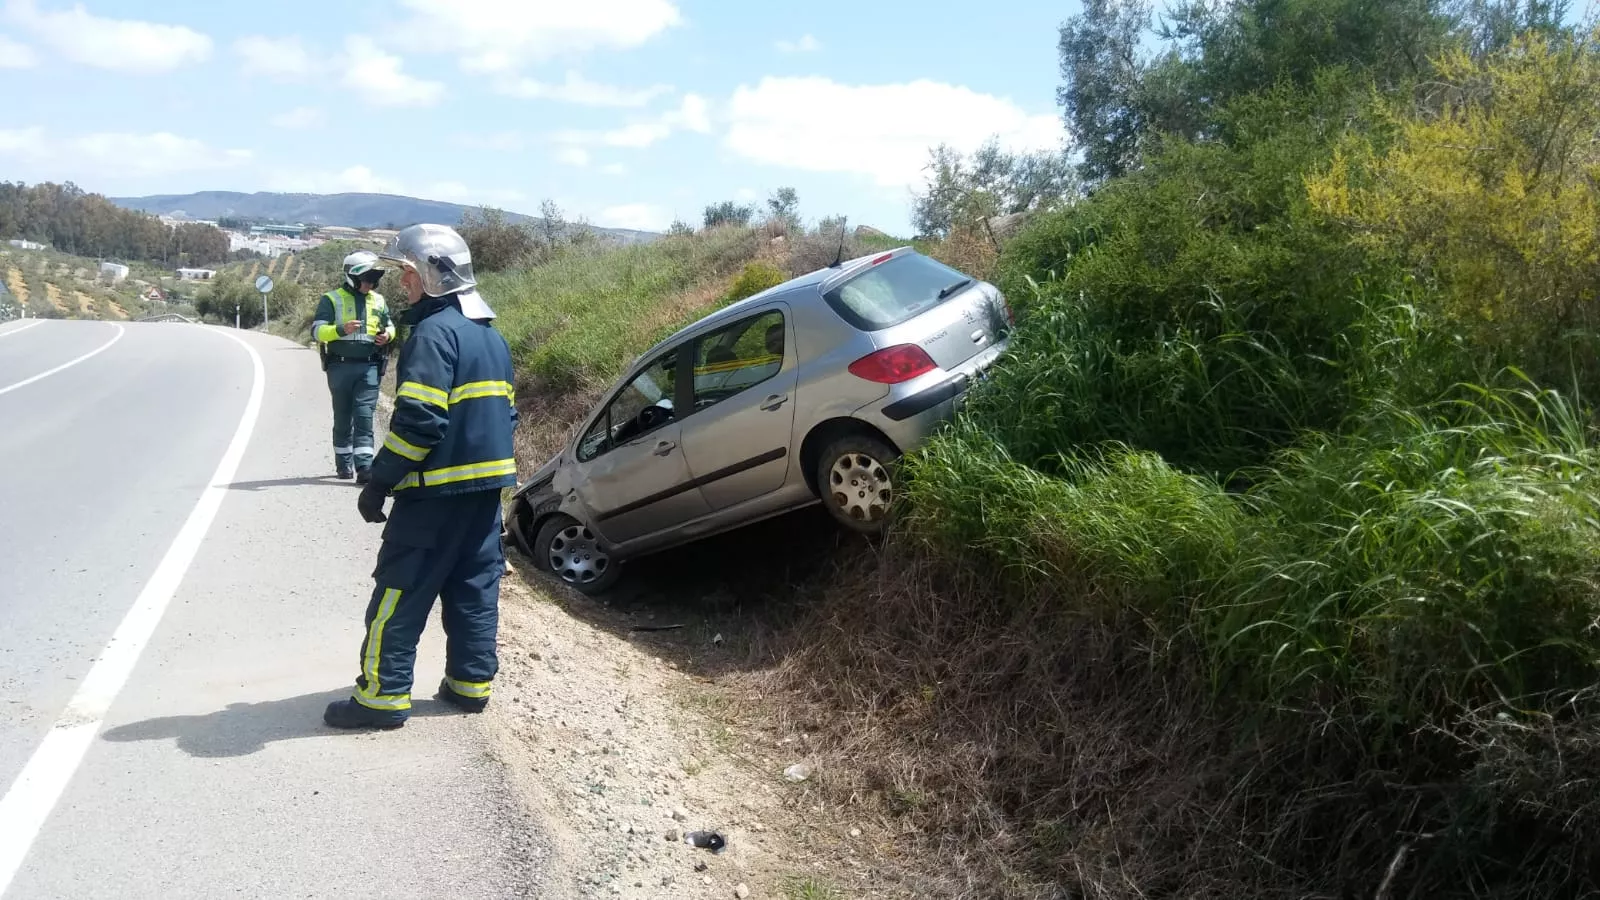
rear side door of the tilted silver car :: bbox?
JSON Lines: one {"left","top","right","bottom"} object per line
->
{"left": 682, "top": 303, "right": 797, "bottom": 511}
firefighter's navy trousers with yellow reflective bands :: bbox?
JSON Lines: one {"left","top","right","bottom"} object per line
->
{"left": 352, "top": 490, "right": 506, "bottom": 717}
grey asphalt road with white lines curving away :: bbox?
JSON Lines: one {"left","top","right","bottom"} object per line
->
{"left": 0, "top": 320, "right": 547, "bottom": 900}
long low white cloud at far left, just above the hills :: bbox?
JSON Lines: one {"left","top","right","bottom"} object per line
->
{"left": 0, "top": 127, "right": 251, "bottom": 183}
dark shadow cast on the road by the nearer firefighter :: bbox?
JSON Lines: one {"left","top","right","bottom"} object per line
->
{"left": 102, "top": 687, "right": 464, "bottom": 759}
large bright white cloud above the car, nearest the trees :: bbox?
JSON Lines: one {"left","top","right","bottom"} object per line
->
{"left": 725, "top": 77, "right": 1066, "bottom": 187}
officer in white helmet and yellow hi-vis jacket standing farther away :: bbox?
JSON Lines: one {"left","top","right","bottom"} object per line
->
{"left": 310, "top": 250, "right": 395, "bottom": 484}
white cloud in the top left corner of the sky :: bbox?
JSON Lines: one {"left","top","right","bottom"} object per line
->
{"left": 5, "top": 0, "right": 211, "bottom": 72}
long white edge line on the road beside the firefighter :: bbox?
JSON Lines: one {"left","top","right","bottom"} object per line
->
{"left": 0, "top": 323, "right": 267, "bottom": 895}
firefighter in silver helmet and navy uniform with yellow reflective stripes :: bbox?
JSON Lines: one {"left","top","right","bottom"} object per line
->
{"left": 323, "top": 224, "right": 517, "bottom": 729}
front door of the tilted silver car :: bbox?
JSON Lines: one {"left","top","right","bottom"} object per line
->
{"left": 573, "top": 342, "right": 709, "bottom": 544}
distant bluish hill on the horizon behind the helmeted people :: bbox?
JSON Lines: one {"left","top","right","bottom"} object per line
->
{"left": 110, "top": 191, "right": 659, "bottom": 242}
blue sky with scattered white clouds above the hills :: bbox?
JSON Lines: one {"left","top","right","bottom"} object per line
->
{"left": 0, "top": 0, "right": 1078, "bottom": 234}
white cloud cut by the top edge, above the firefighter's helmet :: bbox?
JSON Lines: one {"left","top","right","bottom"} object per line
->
{"left": 394, "top": 0, "right": 683, "bottom": 72}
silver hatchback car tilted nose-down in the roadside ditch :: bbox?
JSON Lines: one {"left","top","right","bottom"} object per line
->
{"left": 506, "top": 247, "right": 1011, "bottom": 594}
